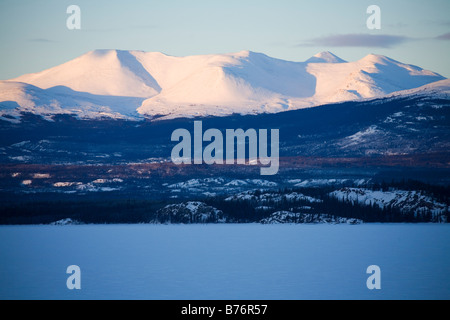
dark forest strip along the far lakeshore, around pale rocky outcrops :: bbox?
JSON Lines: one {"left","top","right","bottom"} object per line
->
{"left": 0, "top": 180, "right": 450, "bottom": 224}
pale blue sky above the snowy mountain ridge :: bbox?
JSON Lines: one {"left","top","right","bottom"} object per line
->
{"left": 0, "top": 0, "right": 450, "bottom": 79}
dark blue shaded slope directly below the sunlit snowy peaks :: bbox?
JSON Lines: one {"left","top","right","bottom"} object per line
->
{"left": 0, "top": 87, "right": 450, "bottom": 164}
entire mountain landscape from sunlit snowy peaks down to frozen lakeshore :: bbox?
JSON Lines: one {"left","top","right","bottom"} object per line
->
{"left": 0, "top": 50, "right": 450, "bottom": 224}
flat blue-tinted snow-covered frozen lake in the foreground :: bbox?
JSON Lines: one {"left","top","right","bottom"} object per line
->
{"left": 0, "top": 224, "right": 450, "bottom": 300}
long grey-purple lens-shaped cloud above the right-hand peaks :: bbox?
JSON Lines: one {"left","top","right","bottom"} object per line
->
{"left": 298, "top": 34, "right": 411, "bottom": 48}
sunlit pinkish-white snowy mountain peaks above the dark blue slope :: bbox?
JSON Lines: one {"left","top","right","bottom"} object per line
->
{"left": 0, "top": 50, "right": 448, "bottom": 119}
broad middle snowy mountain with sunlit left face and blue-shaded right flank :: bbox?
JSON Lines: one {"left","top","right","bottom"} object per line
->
{"left": 138, "top": 51, "right": 315, "bottom": 116}
